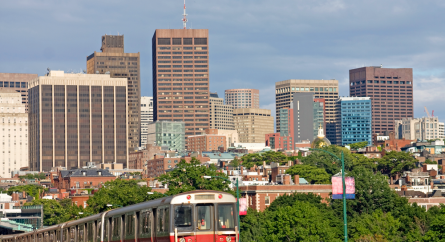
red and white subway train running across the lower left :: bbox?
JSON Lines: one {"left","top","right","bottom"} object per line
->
{"left": 0, "top": 190, "right": 239, "bottom": 242}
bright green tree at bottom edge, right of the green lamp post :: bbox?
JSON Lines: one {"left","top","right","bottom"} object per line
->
{"left": 348, "top": 210, "right": 402, "bottom": 241}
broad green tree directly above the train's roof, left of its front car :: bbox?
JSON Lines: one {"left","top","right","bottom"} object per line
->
{"left": 87, "top": 179, "right": 164, "bottom": 213}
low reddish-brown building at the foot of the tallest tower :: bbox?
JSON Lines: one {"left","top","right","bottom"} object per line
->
{"left": 188, "top": 129, "right": 227, "bottom": 152}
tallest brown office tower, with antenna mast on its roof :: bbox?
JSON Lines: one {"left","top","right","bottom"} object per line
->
{"left": 152, "top": 29, "right": 210, "bottom": 137}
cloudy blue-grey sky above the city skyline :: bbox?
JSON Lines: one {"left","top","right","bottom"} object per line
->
{"left": 0, "top": 0, "right": 445, "bottom": 125}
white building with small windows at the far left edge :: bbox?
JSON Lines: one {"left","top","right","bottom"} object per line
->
{"left": 0, "top": 88, "right": 28, "bottom": 178}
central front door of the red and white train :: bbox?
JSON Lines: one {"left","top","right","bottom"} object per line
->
{"left": 195, "top": 203, "right": 215, "bottom": 242}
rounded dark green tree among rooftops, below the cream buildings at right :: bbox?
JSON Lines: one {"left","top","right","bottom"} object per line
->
{"left": 377, "top": 151, "right": 417, "bottom": 175}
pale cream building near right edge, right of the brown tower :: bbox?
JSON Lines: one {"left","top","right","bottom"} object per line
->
{"left": 394, "top": 117, "right": 444, "bottom": 140}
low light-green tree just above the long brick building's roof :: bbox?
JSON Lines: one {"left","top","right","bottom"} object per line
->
{"left": 286, "top": 165, "right": 331, "bottom": 184}
